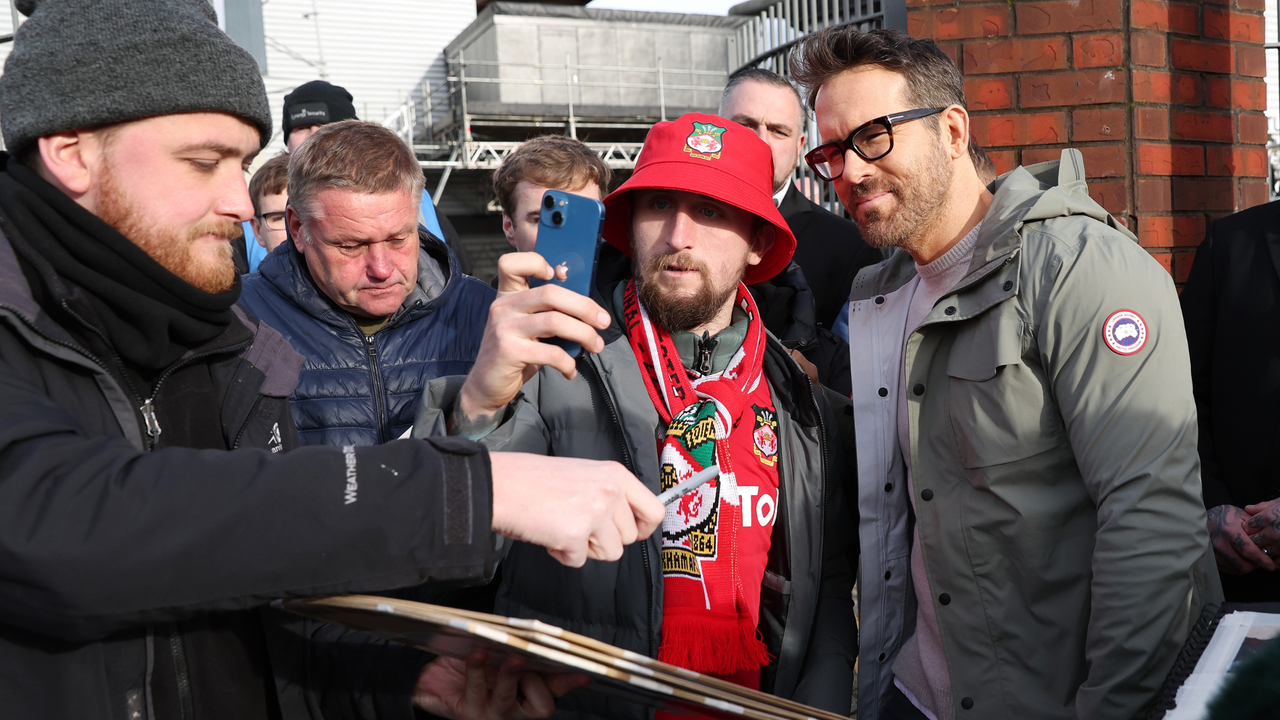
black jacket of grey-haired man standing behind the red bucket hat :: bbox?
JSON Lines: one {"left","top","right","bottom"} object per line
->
{"left": 778, "top": 183, "right": 884, "bottom": 329}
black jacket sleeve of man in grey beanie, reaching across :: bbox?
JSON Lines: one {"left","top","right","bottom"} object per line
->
{"left": 0, "top": 358, "right": 495, "bottom": 642}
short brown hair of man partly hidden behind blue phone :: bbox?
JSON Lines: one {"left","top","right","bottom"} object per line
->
{"left": 493, "top": 135, "right": 613, "bottom": 218}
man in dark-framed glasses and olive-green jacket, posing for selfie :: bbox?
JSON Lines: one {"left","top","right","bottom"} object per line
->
{"left": 791, "top": 27, "right": 1221, "bottom": 720}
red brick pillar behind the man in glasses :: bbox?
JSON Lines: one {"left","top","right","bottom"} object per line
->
{"left": 906, "top": 0, "right": 1267, "bottom": 283}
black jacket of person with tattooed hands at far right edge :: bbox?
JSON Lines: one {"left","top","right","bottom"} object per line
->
{"left": 1181, "top": 202, "right": 1280, "bottom": 602}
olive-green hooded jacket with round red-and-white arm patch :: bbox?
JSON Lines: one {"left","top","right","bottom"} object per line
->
{"left": 849, "top": 150, "right": 1221, "bottom": 720}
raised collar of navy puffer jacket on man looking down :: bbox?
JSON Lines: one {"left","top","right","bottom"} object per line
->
{"left": 257, "top": 227, "right": 462, "bottom": 329}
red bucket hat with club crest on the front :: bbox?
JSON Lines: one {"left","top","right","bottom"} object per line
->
{"left": 604, "top": 113, "right": 796, "bottom": 284}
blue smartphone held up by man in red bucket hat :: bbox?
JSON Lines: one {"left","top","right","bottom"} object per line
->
{"left": 529, "top": 190, "right": 604, "bottom": 357}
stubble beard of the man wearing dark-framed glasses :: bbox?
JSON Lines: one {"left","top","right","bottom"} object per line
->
{"left": 849, "top": 139, "right": 955, "bottom": 254}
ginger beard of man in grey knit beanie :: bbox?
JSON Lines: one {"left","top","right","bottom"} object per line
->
{"left": 96, "top": 164, "right": 242, "bottom": 295}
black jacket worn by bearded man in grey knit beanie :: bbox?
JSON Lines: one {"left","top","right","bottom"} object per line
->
{"left": 0, "top": 214, "right": 495, "bottom": 720}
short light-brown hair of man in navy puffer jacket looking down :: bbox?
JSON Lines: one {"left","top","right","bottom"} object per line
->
{"left": 289, "top": 120, "right": 425, "bottom": 215}
